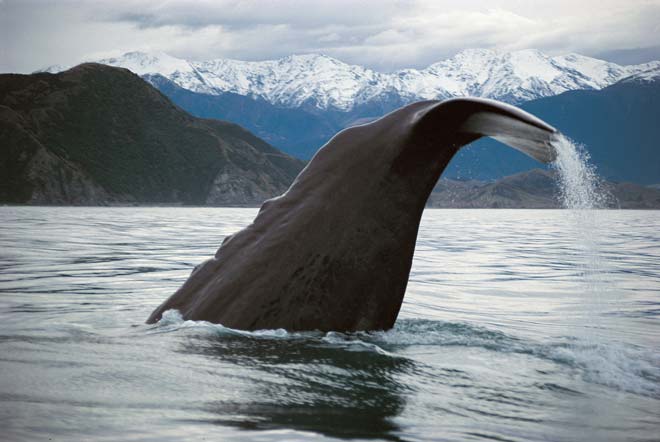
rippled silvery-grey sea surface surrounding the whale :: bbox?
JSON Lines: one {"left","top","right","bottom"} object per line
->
{"left": 0, "top": 207, "right": 660, "bottom": 441}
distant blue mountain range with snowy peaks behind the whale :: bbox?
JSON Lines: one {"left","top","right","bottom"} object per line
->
{"left": 42, "top": 49, "right": 660, "bottom": 184}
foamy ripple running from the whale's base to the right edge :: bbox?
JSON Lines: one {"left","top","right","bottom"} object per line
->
{"left": 147, "top": 310, "right": 660, "bottom": 397}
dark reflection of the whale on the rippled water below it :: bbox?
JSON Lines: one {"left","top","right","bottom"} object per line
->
{"left": 184, "top": 337, "right": 412, "bottom": 439}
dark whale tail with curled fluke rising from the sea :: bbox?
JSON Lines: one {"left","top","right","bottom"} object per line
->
{"left": 147, "top": 98, "right": 556, "bottom": 331}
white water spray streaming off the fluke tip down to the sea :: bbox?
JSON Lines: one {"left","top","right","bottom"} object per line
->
{"left": 552, "top": 135, "right": 631, "bottom": 394}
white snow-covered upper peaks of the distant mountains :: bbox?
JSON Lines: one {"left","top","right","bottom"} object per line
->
{"left": 43, "top": 49, "right": 660, "bottom": 111}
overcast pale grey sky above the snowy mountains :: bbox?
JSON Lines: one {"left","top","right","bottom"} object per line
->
{"left": 0, "top": 0, "right": 660, "bottom": 72}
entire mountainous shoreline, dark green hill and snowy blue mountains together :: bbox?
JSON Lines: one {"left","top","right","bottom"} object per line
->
{"left": 6, "top": 50, "right": 660, "bottom": 208}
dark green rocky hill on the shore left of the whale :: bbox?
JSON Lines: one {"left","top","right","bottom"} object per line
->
{"left": 0, "top": 64, "right": 303, "bottom": 205}
